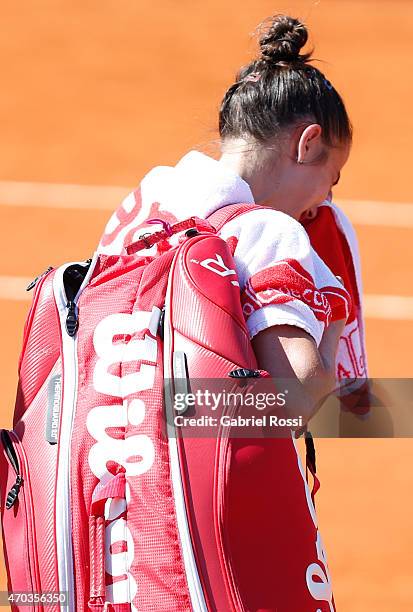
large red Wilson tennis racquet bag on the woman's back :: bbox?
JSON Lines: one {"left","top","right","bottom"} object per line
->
{"left": 0, "top": 207, "right": 335, "bottom": 612}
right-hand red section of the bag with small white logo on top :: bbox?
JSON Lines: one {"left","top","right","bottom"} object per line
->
{"left": 171, "top": 236, "right": 335, "bottom": 612}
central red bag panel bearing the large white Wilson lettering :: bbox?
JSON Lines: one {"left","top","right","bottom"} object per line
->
{"left": 71, "top": 251, "right": 190, "bottom": 612}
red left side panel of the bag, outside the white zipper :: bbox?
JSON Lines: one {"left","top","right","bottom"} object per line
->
{"left": 0, "top": 272, "right": 62, "bottom": 612}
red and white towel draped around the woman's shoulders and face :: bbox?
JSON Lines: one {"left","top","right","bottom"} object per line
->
{"left": 98, "top": 151, "right": 367, "bottom": 412}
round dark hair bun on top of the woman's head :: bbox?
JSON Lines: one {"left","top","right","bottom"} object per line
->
{"left": 259, "top": 15, "right": 311, "bottom": 63}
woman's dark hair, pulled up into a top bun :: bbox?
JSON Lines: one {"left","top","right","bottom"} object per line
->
{"left": 219, "top": 15, "right": 352, "bottom": 146}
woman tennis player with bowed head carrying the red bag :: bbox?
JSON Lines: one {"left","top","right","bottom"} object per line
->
{"left": 100, "top": 15, "right": 352, "bottom": 420}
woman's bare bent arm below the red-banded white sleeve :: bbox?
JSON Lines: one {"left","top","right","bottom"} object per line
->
{"left": 252, "top": 319, "right": 345, "bottom": 423}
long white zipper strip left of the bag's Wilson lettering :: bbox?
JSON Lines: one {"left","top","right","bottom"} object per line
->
{"left": 53, "top": 253, "right": 98, "bottom": 612}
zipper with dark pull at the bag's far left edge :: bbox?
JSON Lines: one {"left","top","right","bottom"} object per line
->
{"left": 1, "top": 429, "right": 42, "bottom": 612}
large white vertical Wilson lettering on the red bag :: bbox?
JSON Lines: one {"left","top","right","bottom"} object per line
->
{"left": 86, "top": 312, "right": 157, "bottom": 610}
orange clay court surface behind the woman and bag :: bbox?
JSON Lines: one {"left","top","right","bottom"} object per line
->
{"left": 0, "top": 0, "right": 413, "bottom": 612}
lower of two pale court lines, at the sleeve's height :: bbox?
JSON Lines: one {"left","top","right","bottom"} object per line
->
{"left": 0, "top": 276, "right": 413, "bottom": 321}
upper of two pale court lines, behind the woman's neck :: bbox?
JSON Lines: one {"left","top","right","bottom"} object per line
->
{"left": 0, "top": 181, "right": 413, "bottom": 228}
